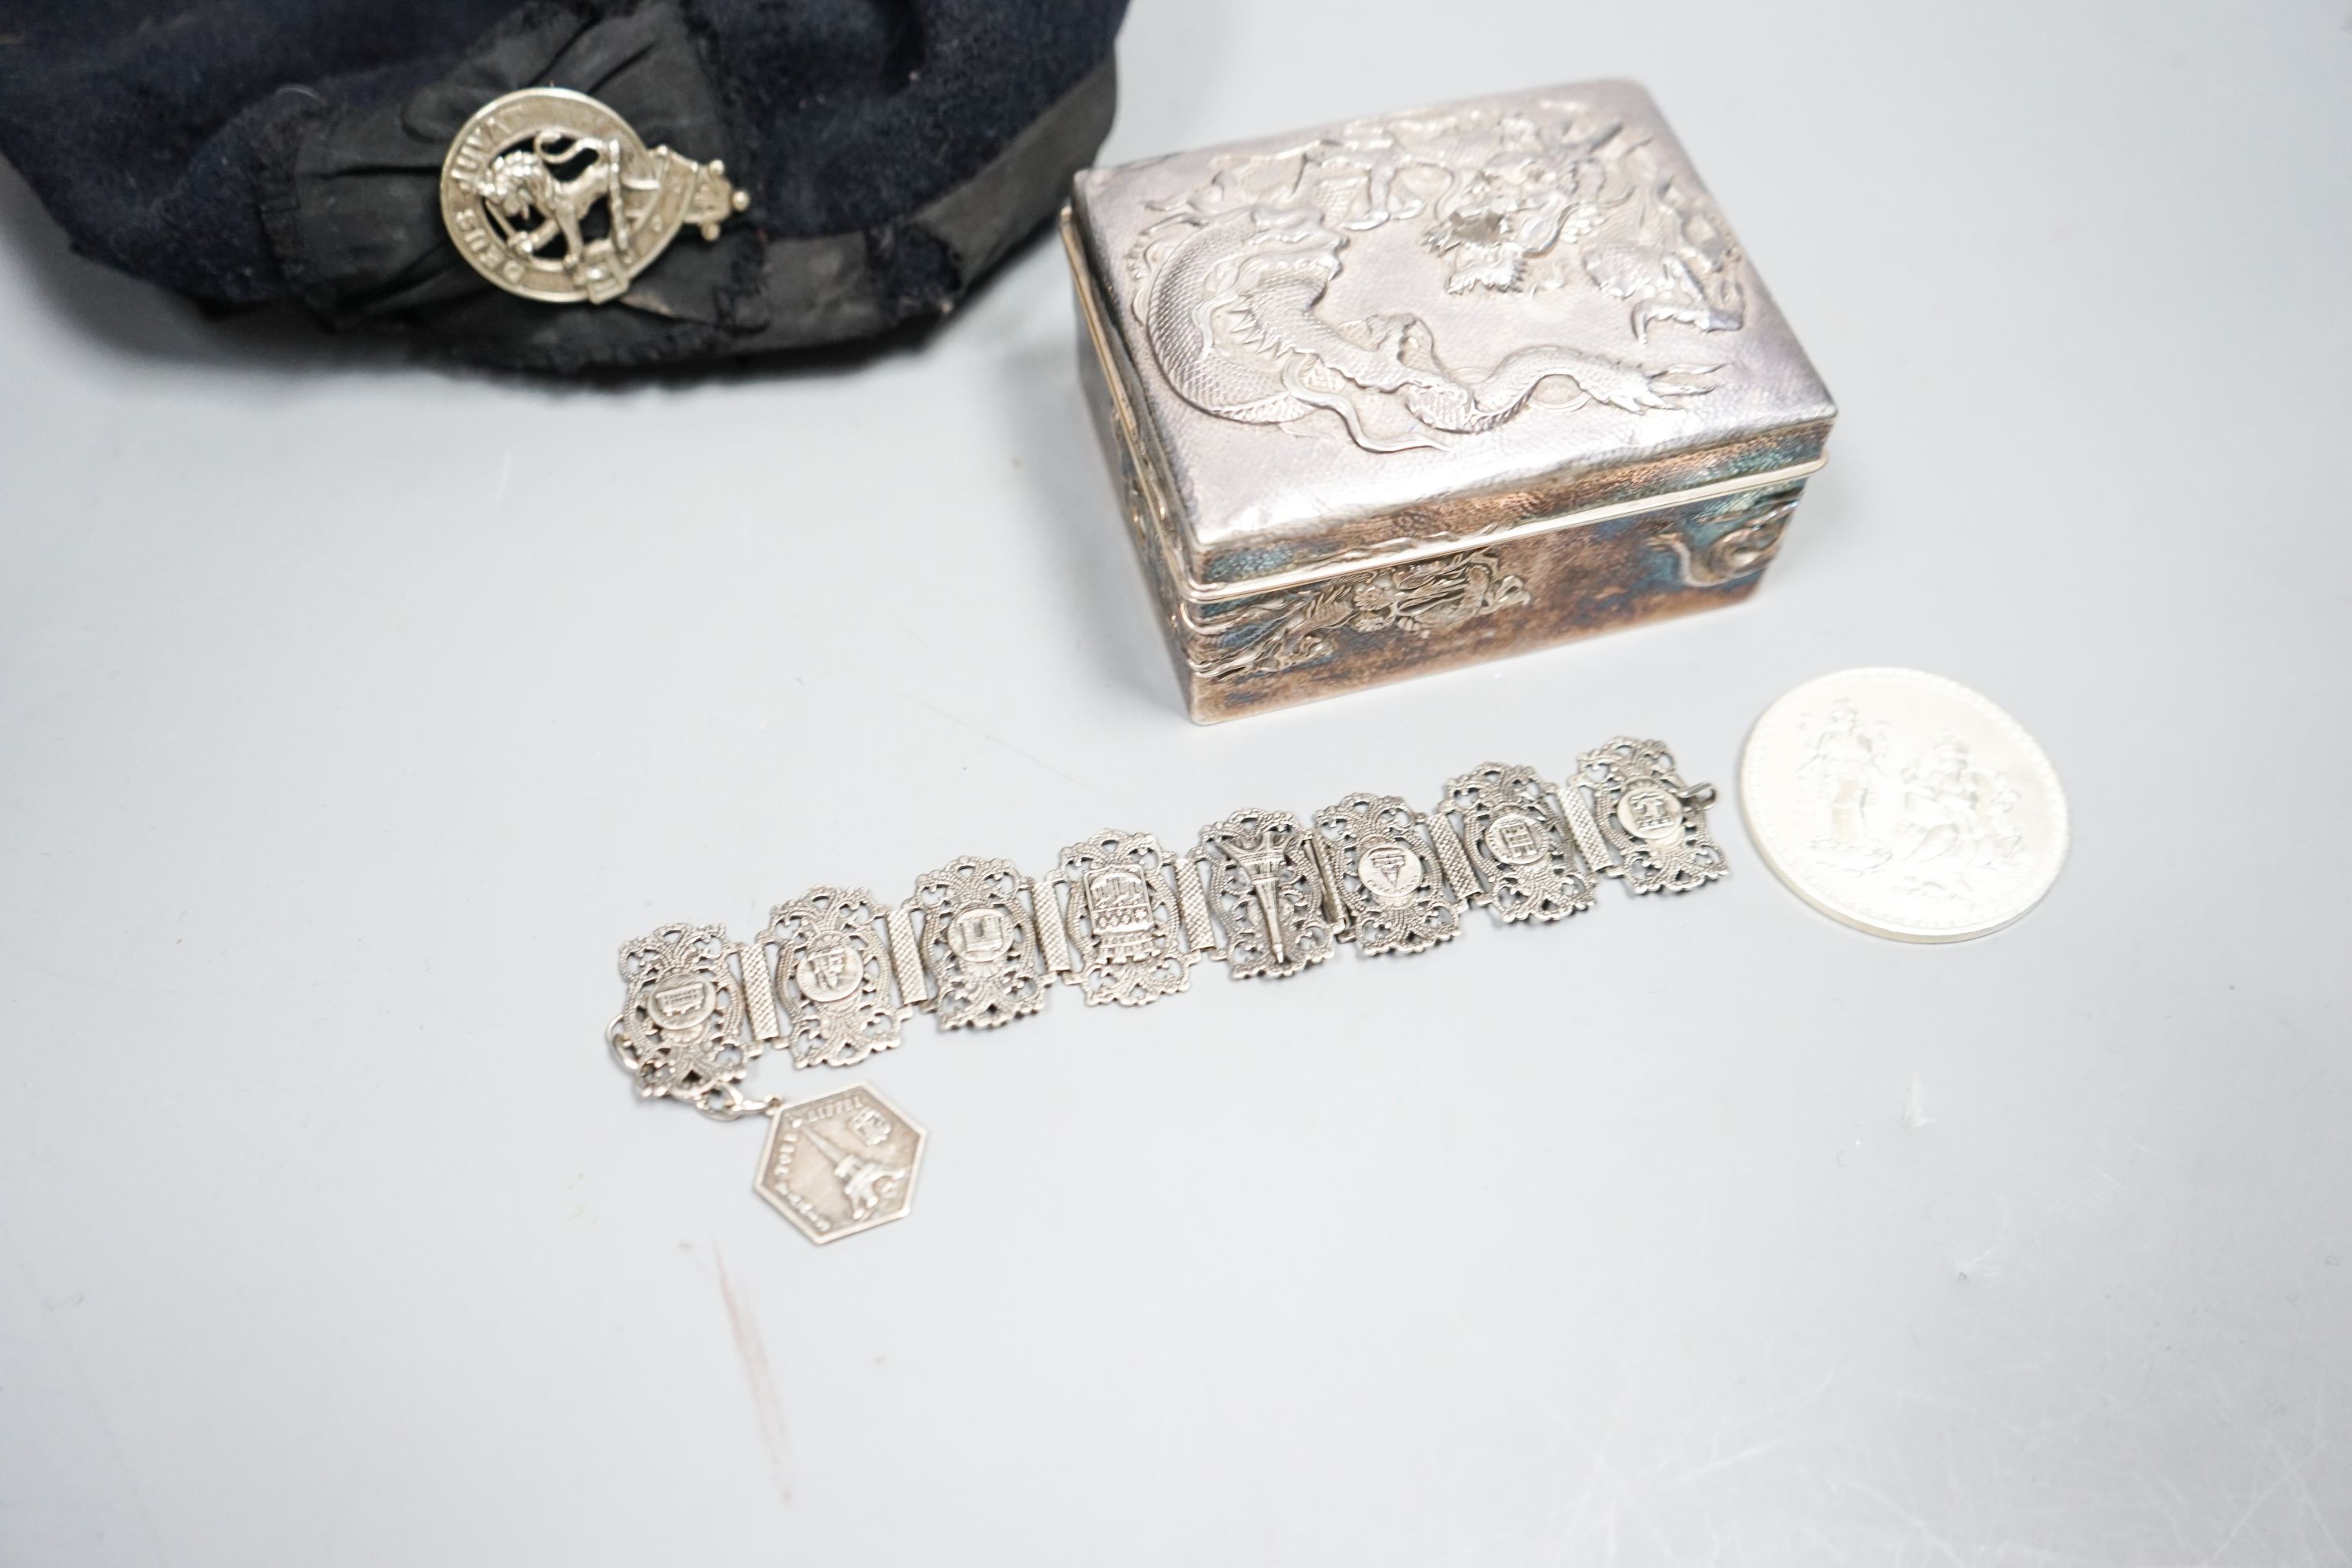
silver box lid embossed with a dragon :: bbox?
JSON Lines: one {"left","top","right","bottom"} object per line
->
{"left": 1063, "top": 82, "right": 1837, "bottom": 600}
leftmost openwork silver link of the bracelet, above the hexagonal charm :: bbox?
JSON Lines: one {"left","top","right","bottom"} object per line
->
{"left": 604, "top": 924, "right": 760, "bottom": 1109}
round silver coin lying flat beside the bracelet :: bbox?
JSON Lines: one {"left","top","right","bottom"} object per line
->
{"left": 1740, "top": 670, "right": 2067, "bottom": 942}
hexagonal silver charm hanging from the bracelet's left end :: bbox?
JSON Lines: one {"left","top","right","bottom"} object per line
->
{"left": 753, "top": 1083, "right": 924, "bottom": 1243}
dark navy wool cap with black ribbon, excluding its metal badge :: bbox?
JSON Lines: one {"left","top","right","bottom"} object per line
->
{"left": 0, "top": 0, "right": 1127, "bottom": 372}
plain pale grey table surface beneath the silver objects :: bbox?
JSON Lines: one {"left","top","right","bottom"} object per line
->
{"left": 0, "top": 0, "right": 2352, "bottom": 1568}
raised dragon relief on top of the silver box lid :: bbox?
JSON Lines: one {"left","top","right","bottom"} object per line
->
{"left": 1127, "top": 103, "right": 1748, "bottom": 452}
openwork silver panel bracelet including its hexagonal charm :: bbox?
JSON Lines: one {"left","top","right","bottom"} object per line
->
{"left": 607, "top": 736, "right": 1724, "bottom": 1241}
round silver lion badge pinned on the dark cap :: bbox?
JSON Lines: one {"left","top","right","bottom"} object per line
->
{"left": 440, "top": 87, "right": 750, "bottom": 306}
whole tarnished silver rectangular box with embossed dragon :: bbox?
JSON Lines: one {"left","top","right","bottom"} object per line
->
{"left": 1063, "top": 82, "right": 1837, "bottom": 722}
